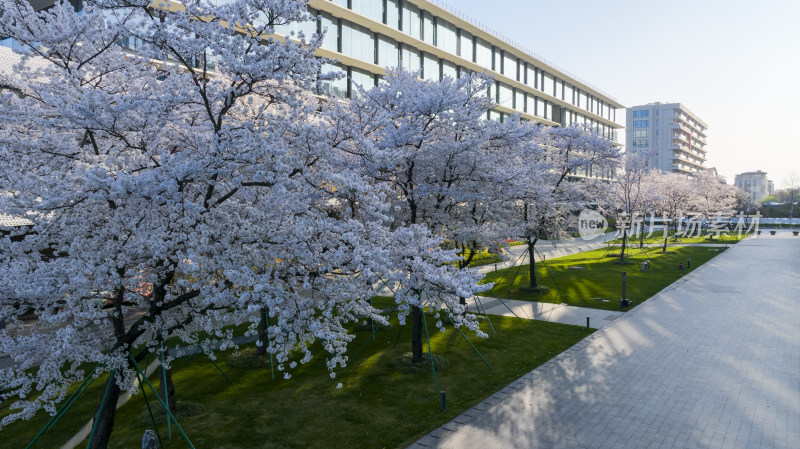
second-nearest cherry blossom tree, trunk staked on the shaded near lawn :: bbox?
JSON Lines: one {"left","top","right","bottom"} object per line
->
{"left": 336, "top": 69, "right": 527, "bottom": 363}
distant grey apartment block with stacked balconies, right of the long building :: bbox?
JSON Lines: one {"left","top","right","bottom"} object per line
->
{"left": 625, "top": 103, "right": 708, "bottom": 175}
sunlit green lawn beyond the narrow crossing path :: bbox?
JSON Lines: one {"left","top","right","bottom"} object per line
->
{"left": 483, "top": 246, "right": 725, "bottom": 310}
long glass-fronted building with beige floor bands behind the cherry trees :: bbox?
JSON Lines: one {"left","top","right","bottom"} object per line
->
{"left": 0, "top": 0, "right": 624, "bottom": 177}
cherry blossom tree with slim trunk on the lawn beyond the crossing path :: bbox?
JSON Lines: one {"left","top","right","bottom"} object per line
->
{"left": 515, "top": 126, "right": 619, "bottom": 288}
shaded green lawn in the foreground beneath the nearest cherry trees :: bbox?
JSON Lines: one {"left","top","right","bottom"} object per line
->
{"left": 0, "top": 312, "right": 590, "bottom": 448}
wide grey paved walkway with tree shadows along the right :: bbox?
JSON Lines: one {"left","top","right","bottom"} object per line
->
{"left": 412, "top": 232, "right": 800, "bottom": 449}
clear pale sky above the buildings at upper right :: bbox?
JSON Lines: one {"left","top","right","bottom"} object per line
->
{"left": 439, "top": 0, "right": 800, "bottom": 188}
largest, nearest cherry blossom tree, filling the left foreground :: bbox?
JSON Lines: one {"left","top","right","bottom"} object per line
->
{"left": 0, "top": 0, "right": 390, "bottom": 448}
